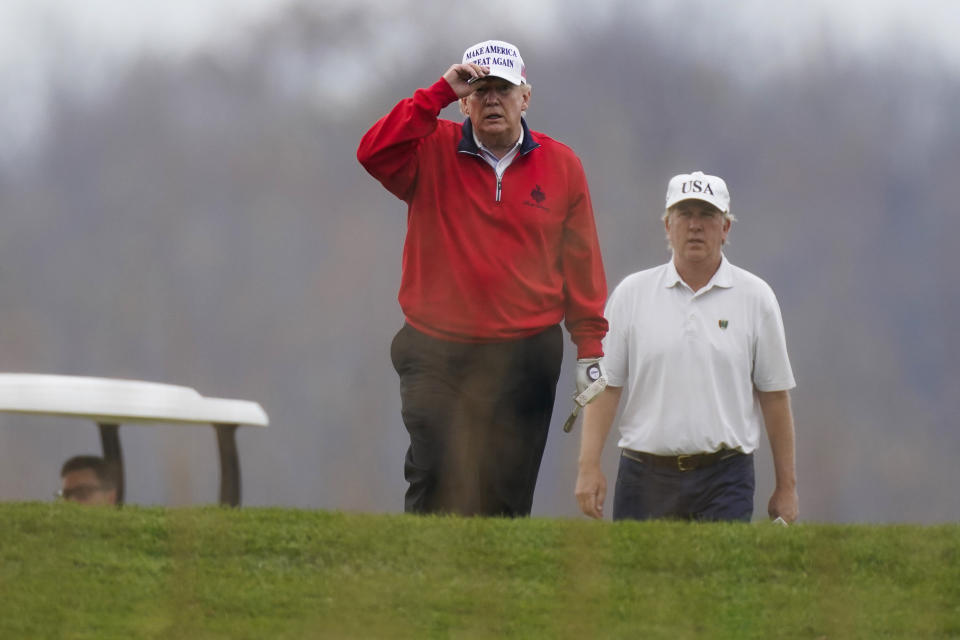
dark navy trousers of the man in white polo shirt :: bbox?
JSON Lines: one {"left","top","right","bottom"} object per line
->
{"left": 613, "top": 451, "right": 754, "bottom": 522}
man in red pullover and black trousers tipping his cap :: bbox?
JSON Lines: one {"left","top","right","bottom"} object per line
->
{"left": 357, "top": 40, "right": 607, "bottom": 516}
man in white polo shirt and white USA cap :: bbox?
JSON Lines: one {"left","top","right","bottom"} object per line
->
{"left": 576, "top": 171, "right": 798, "bottom": 522}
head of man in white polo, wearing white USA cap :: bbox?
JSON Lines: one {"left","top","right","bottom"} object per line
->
{"left": 663, "top": 171, "right": 734, "bottom": 263}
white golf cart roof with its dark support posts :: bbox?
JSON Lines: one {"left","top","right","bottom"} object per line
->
{"left": 0, "top": 373, "right": 269, "bottom": 506}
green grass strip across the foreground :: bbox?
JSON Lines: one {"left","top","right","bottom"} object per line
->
{"left": 0, "top": 503, "right": 960, "bottom": 640}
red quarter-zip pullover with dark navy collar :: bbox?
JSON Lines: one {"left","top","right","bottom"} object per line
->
{"left": 357, "top": 78, "right": 607, "bottom": 358}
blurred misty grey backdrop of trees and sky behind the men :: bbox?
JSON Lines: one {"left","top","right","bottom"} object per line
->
{"left": 0, "top": 0, "right": 960, "bottom": 523}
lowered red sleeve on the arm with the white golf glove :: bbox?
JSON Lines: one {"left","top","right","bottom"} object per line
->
{"left": 561, "top": 159, "right": 608, "bottom": 358}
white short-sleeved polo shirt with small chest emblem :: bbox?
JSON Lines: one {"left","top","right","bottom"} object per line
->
{"left": 603, "top": 257, "right": 796, "bottom": 455}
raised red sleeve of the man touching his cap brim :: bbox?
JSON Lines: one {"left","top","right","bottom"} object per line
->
{"left": 357, "top": 78, "right": 457, "bottom": 200}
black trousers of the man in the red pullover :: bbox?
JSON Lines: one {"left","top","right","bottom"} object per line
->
{"left": 390, "top": 325, "right": 563, "bottom": 516}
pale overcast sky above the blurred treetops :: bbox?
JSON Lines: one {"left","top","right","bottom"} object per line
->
{"left": 0, "top": 0, "right": 960, "bottom": 160}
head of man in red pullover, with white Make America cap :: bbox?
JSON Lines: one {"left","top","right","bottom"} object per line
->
{"left": 460, "top": 40, "right": 530, "bottom": 148}
